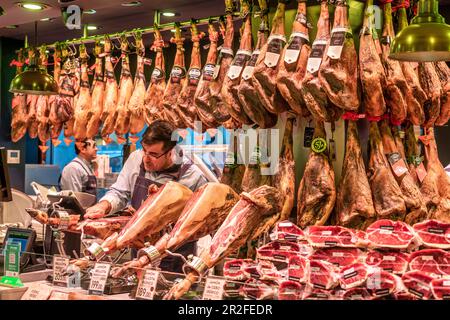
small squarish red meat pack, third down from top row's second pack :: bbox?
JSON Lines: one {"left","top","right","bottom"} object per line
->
{"left": 309, "top": 260, "right": 339, "bottom": 290}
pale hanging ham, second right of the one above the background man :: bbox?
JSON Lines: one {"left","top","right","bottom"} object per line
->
{"left": 101, "top": 37, "right": 119, "bottom": 143}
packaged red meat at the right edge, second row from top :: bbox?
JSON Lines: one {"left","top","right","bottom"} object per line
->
{"left": 409, "top": 249, "right": 450, "bottom": 278}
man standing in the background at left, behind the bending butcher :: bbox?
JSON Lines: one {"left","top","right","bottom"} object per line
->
{"left": 60, "top": 139, "right": 97, "bottom": 196}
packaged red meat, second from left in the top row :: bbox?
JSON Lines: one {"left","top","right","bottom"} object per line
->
{"left": 305, "top": 226, "right": 359, "bottom": 248}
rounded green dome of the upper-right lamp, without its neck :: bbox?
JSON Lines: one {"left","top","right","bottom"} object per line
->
{"left": 389, "top": 22, "right": 450, "bottom": 62}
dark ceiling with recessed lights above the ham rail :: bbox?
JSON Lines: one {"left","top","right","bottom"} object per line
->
{"left": 0, "top": 0, "right": 450, "bottom": 44}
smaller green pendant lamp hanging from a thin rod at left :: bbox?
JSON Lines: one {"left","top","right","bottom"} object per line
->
{"left": 9, "top": 21, "right": 58, "bottom": 95}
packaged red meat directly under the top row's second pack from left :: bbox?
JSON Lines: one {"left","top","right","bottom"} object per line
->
{"left": 309, "top": 247, "right": 362, "bottom": 268}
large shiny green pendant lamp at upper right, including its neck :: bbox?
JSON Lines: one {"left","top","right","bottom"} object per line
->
{"left": 389, "top": 0, "right": 450, "bottom": 62}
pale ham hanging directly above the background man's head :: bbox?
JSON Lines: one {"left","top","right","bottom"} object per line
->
{"left": 73, "top": 45, "right": 92, "bottom": 141}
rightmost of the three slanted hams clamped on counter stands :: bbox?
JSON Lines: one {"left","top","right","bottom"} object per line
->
{"left": 165, "top": 186, "right": 281, "bottom": 299}
